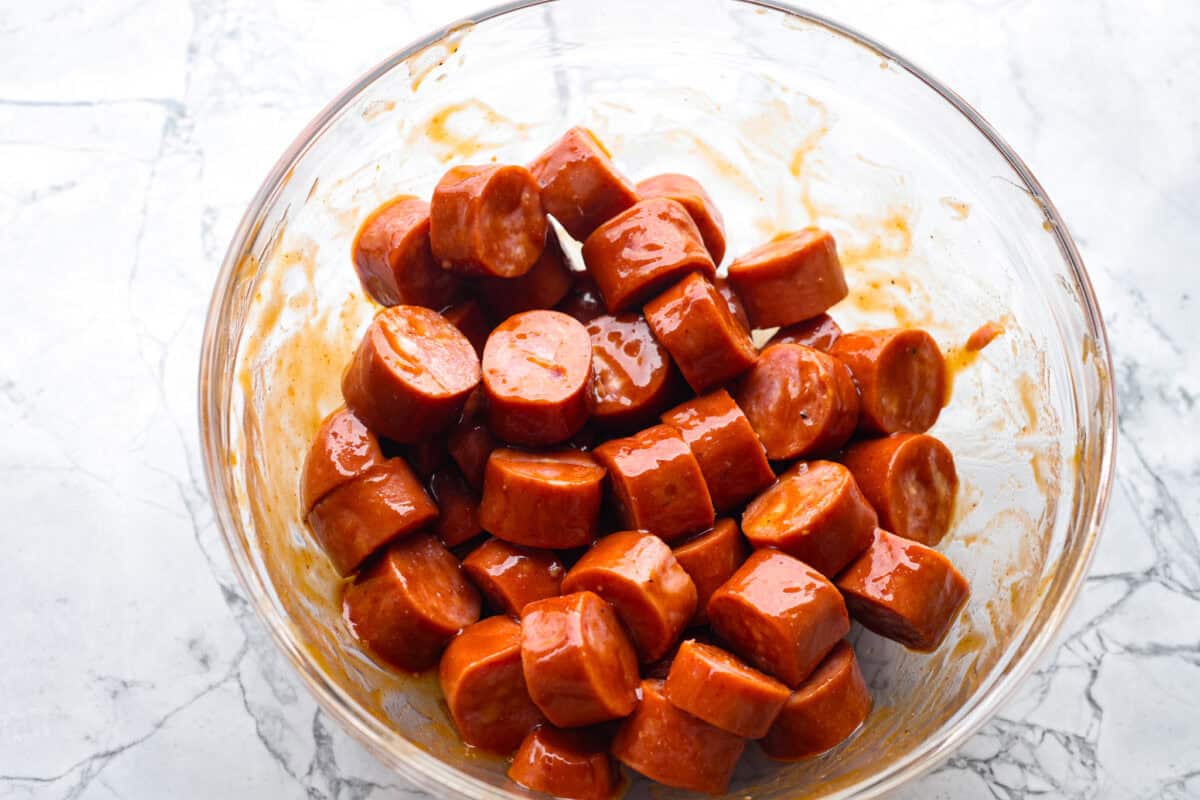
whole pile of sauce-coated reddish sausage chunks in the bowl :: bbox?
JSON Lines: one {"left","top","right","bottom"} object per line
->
{"left": 301, "top": 128, "right": 968, "bottom": 800}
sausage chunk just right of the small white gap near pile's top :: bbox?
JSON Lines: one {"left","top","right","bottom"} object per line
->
{"left": 583, "top": 197, "right": 716, "bottom": 313}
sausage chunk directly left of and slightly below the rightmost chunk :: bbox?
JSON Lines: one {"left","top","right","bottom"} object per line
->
{"left": 708, "top": 551, "right": 850, "bottom": 687}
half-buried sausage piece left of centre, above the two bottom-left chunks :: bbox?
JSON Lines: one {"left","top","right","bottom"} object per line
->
{"left": 462, "top": 539, "right": 566, "bottom": 616}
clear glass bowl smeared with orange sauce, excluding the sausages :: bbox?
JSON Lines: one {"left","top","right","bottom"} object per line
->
{"left": 199, "top": 0, "right": 1115, "bottom": 799}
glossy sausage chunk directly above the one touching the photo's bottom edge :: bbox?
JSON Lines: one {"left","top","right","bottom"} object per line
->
{"left": 521, "top": 591, "right": 637, "bottom": 728}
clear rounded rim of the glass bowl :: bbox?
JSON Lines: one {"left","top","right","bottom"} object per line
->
{"left": 198, "top": 0, "right": 1117, "bottom": 800}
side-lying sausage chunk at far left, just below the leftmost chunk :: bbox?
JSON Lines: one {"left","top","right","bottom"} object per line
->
{"left": 307, "top": 458, "right": 438, "bottom": 576}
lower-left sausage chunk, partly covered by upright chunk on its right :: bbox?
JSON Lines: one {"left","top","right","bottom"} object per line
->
{"left": 438, "top": 616, "right": 542, "bottom": 756}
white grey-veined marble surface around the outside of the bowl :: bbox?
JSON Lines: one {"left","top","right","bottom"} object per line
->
{"left": 0, "top": 0, "right": 1200, "bottom": 799}
